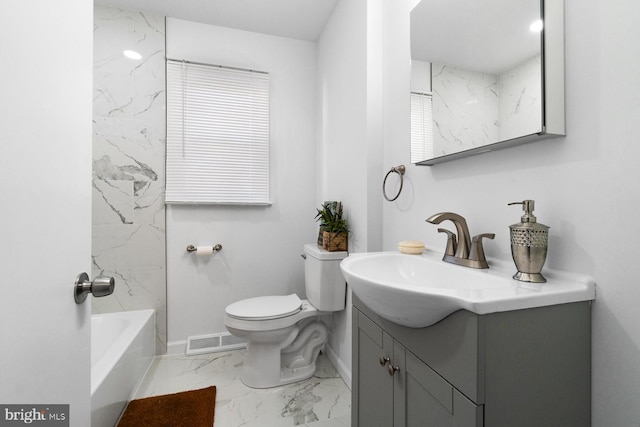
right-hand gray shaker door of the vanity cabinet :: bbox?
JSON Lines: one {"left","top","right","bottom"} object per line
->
{"left": 402, "top": 352, "right": 483, "bottom": 427}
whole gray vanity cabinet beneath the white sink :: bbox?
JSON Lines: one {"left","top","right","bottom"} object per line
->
{"left": 352, "top": 295, "right": 591, "bottom": 427}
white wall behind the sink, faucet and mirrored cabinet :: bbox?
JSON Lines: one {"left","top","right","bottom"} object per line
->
{"left": 382, "top": 0, "right": 640, "bottom": 426}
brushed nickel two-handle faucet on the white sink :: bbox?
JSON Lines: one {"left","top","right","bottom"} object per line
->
{"left": 426, "top": 212, "right": 495, "bottom": 268}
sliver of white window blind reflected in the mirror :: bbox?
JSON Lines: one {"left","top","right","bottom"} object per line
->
{"left": 411, "top": 92, "right": 433, "bottom": 163}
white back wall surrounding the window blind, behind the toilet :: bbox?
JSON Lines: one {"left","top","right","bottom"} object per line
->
{"left": 167, "top": 18, "right": 318, "bottom": 353}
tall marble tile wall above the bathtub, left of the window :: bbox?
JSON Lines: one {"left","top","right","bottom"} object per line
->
{"left": 92, "top": 4, "right": 167, "bottom": 354}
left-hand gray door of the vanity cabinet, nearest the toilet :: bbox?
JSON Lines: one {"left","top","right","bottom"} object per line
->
{"left": 352, "top": 310, "right": 393, "bottom": 427}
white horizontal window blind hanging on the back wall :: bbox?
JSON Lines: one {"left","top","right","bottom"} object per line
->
{"left": 165, "top": 60, "right": 270, "bottom": 204}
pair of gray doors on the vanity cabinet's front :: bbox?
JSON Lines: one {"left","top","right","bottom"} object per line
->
{"left": 352, "top": 308, "right": 483, "bottom": 427}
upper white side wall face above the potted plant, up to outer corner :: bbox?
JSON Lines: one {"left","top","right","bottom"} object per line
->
{"left": 318, "top": 0, "right": 367, "bottom": 244}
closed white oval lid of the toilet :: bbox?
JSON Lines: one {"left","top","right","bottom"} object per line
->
{"left": 226, "top": 294, "right": 302, "bottom": 320}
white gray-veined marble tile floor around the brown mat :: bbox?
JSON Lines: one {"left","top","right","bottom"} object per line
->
{"left": 134, "top": 350, "right": 351, "bottom": 427}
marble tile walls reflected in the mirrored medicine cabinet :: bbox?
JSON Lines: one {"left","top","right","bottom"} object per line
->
{"left": 432, "top": 55, "right": 542, "bottom": 156}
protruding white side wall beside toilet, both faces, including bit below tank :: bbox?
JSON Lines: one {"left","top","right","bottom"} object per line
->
{"left": 318, "top": 0, "right": 382, "bottom": 383}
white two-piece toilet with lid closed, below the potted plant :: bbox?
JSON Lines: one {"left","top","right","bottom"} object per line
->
{"left": 224, "top": 243, "right": 347, "bottom": 388}
